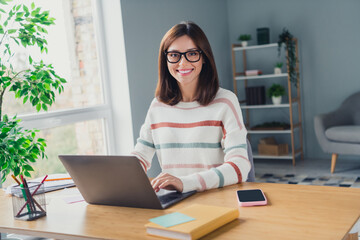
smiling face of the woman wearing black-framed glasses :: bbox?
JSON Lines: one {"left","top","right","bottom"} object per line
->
{"left": 167, "top": 35, "right": 203, "bottom": 91}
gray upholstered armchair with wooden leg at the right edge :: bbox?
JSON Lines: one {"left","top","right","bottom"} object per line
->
{"left": 314, "top": 92, "right": 360, "bottom": 173}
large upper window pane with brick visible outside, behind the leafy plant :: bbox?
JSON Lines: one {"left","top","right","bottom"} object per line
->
{"left": 3, "top": 0, "right": 104, "bottom": 115}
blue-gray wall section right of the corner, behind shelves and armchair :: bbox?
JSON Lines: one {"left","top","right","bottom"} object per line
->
{"left": 227, "top": 0, "right": 360, "bottom": 159}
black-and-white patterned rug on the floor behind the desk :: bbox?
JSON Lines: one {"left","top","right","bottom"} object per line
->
{"left": 255, "top": 173, "right": 360, "bottom": 188}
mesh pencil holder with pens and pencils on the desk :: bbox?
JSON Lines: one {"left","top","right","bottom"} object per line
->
{"left": 11, "top": 182, "right": 46, "bottom": 221}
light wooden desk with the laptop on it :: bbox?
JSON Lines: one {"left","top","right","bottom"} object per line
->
{"left": 0, "top": 183, "right": 360, "bottom": 240}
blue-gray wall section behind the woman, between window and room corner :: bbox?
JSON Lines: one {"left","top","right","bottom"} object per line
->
{"left": 121, "top": 0, "right": 232, "bottom": 176}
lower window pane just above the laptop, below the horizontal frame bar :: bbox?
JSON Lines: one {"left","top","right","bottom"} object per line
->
{"left": 3, "top": 119, "right": 107, "bottom": 187}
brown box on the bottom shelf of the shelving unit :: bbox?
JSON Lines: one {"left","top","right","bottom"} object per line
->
{"left": 258, "top": 137, "right": 289, "bottom": 156}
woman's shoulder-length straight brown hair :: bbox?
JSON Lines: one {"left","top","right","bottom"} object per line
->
{"left": 155, "top": 22, "right": 219, "bottom": 105}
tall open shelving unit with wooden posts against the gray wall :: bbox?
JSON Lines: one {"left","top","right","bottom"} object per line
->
{"left": 231, "top": 39, "right": 304, "bottom": 164}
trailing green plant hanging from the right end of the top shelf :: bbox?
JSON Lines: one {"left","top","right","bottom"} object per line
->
{"left": 278, "top": 28, "right": 298, "bottom": 87}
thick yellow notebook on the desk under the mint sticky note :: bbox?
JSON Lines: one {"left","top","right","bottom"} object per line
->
{"left": 145, "top": 204, "right": 239, "bottom": 239}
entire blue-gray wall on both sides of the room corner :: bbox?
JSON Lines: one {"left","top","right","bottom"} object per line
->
{"left": 121, "top": 0, "right": 360, "bottom": 176}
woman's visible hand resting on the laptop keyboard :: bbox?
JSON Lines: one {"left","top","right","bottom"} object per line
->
{"left": 151, "top": 173, "right": 183, "bottom": 192}
